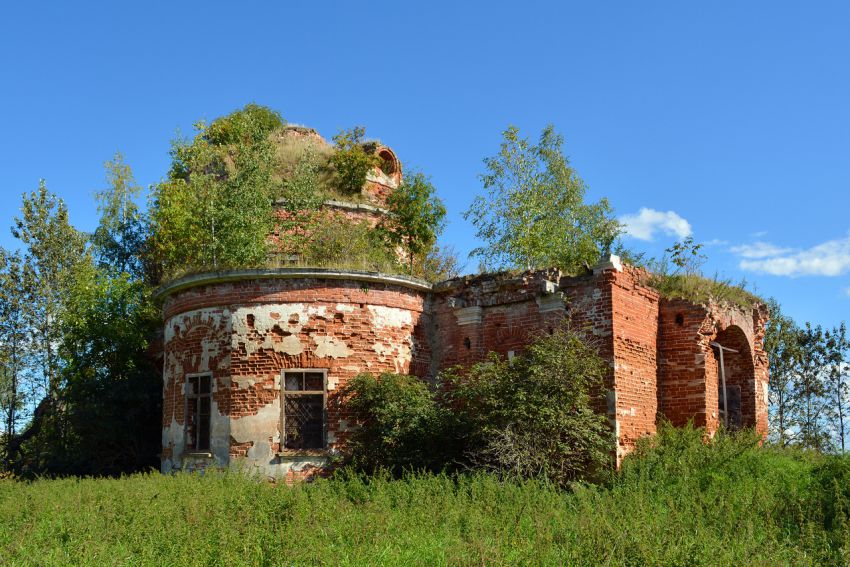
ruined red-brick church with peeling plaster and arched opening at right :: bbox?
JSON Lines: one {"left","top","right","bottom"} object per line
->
{"left": 157, "top": 129, "right": 768, "bottom": 479}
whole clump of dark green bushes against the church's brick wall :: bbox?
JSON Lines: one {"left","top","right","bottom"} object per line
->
{"left": 343, "top": 327, "right": 614, "bottom": 485}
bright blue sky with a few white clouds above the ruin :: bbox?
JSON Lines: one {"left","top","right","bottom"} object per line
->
{"left": 0, "top": 1, "right": 850, "bottom": 325}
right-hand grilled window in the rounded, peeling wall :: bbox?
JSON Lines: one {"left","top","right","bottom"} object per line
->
{"left": 281, "top": 370, "right": 326, "bottom": 451}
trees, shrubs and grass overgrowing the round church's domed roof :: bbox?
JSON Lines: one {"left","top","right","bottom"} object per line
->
{"left": 147, "top": 104, "right": 450, "bottom": 281}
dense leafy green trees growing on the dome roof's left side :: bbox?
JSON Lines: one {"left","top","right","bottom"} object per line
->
{"left": 150, "top": 105, "right": 281, "bottom": 278}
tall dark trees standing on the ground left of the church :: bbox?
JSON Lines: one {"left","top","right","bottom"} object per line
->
{"left": 0, "top": 162, "right": 162, "bottom": 476}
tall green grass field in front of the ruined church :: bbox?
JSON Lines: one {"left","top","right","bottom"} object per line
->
{"left": 0, "top": 430, "right": 850, "bottom": 566}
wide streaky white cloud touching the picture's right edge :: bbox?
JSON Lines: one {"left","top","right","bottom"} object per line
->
{"left": 732, "top": 233, "right": 850, "bottom": 277}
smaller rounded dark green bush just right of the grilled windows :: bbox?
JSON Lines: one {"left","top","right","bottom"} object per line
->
{"left": 341, "top": 372, "right": 449, "bottom": 474}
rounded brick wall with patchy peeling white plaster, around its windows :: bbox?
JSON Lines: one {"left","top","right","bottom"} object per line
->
{"left": 163, "top": 278, "right": 430, "bottom": 479}
